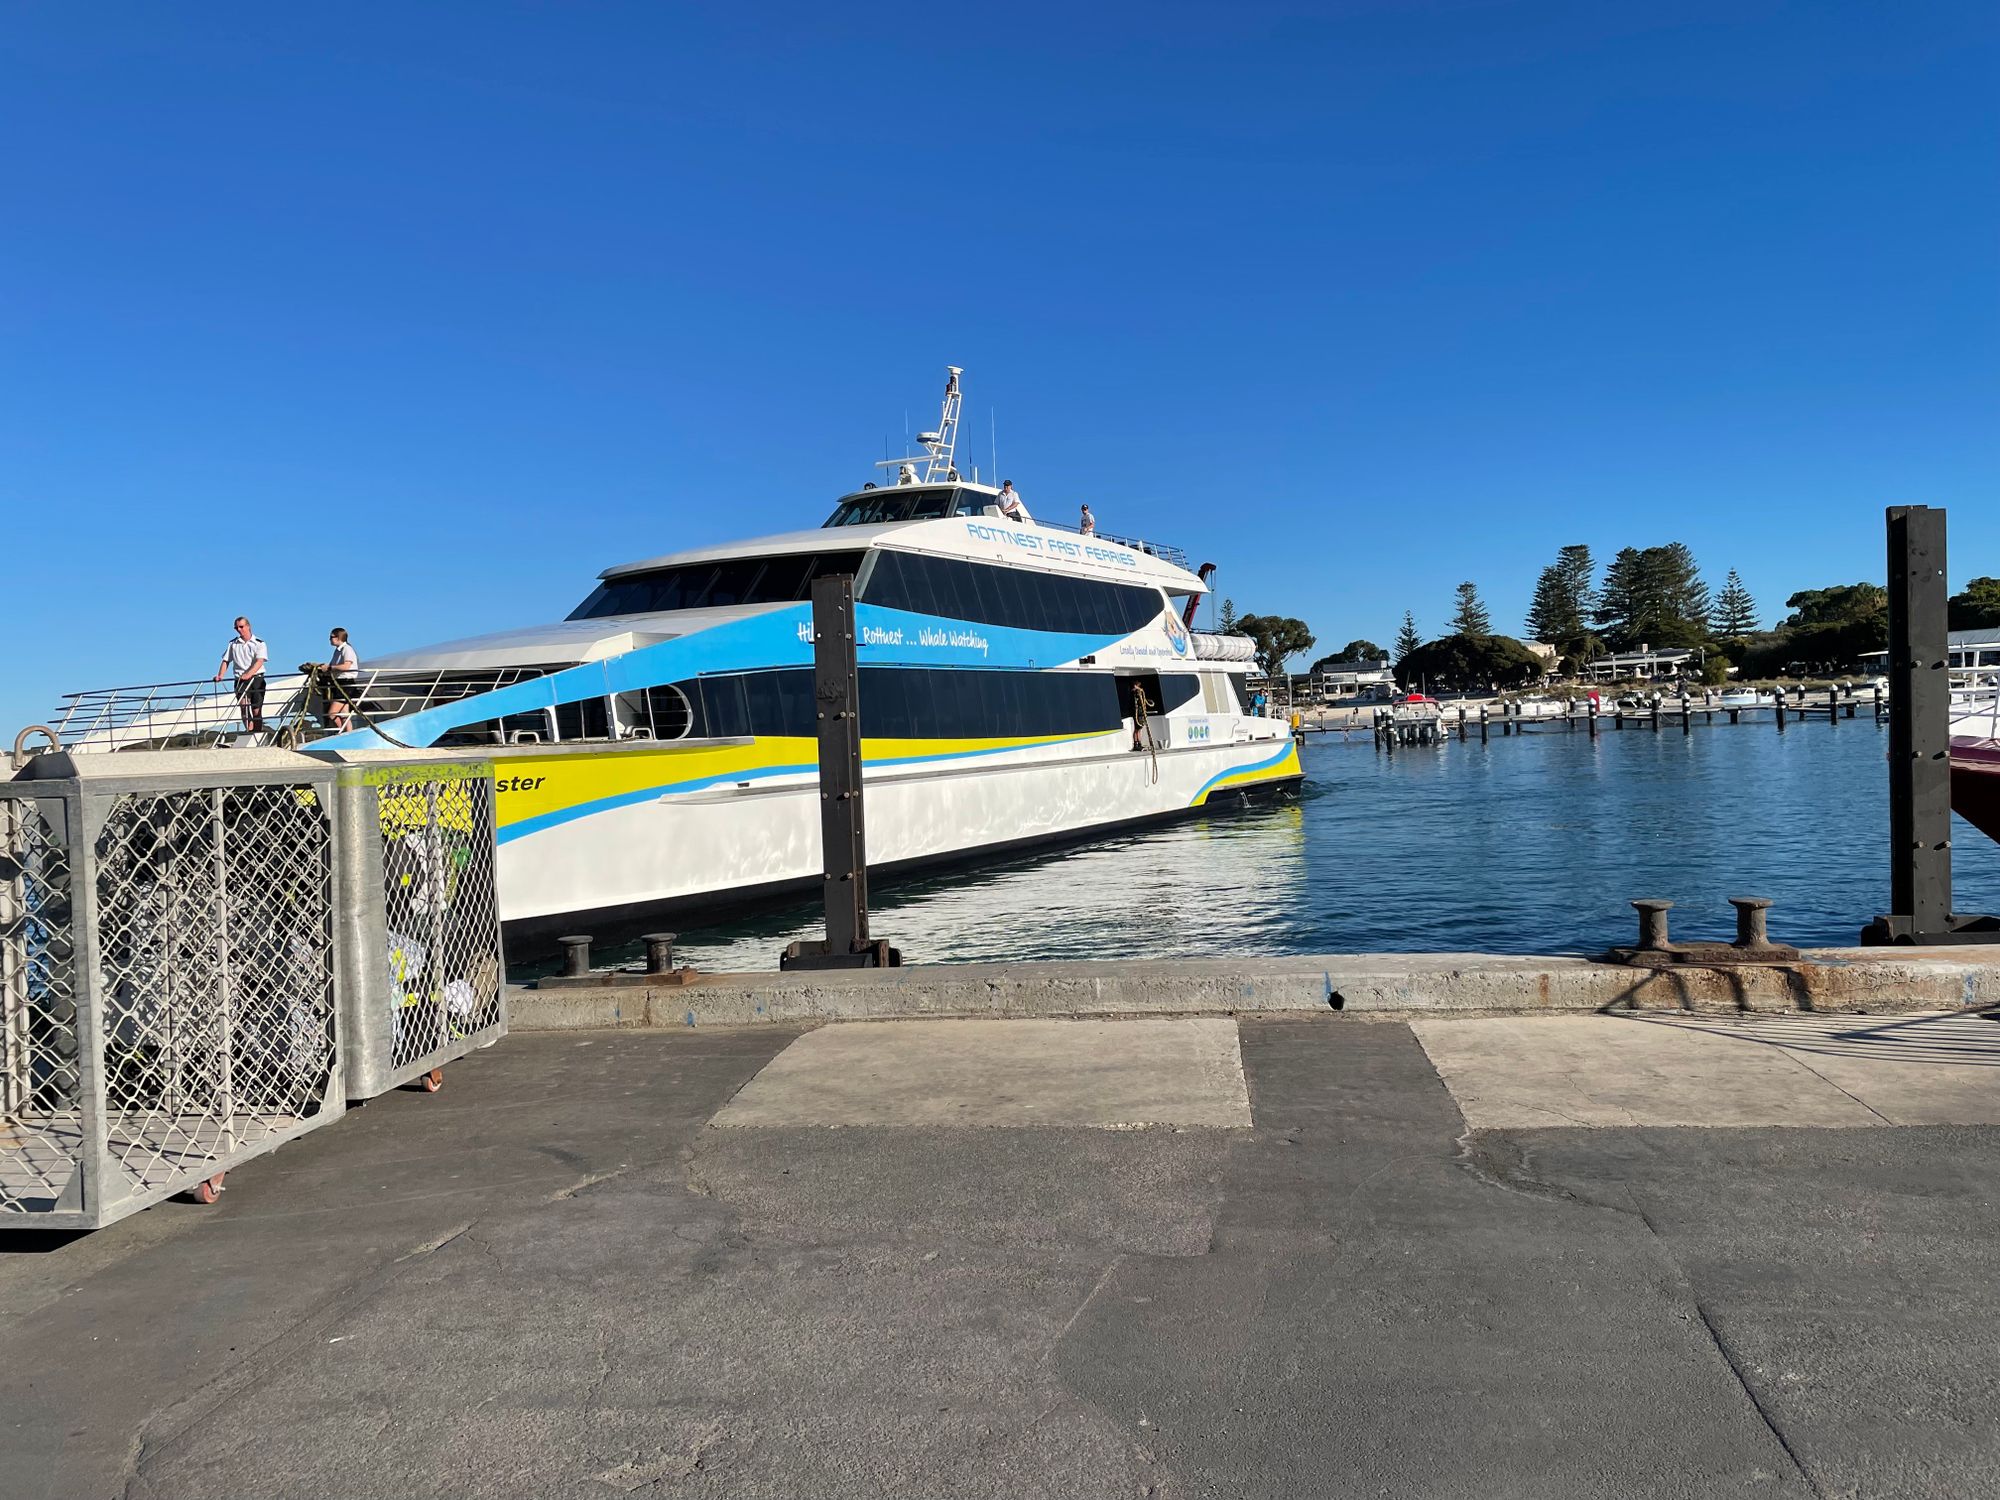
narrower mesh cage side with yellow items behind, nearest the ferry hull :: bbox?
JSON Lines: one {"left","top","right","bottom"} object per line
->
{"left": 328, "top": 752, "right": 506, "bottom": 1098}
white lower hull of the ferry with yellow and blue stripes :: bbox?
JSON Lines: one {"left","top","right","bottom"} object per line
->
{"left": 484, "top": 736, "right": 1302, "bottom": 956}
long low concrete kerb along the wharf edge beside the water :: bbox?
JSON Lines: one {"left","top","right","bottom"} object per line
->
{"left": 508, "top": 948, "right": 2000, "bottom": 1032}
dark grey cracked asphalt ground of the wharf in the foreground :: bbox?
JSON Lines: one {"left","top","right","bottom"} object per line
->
{"left": 0, "top": 1016, "right": 2000, "bottom": 1500}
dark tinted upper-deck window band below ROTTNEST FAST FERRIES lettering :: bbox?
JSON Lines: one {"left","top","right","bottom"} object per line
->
{"left": 862, "top": 552, "right": 1164, "bottom": 636}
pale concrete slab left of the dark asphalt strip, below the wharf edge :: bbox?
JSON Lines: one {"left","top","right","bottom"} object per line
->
{"left": 714, "top": 1018, "right": 1250, "bottom": 1128}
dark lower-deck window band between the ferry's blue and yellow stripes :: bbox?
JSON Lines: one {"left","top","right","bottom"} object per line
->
{"left": 680, "top": 666, "right": 1120, "bottom": 740}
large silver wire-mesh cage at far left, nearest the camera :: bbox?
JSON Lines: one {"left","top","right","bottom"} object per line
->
{"left": 0, "top": 754, "right": 346, "bottom": 1228}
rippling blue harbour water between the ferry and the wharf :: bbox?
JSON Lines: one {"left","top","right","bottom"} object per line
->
{"left": 598, "top": 718, "right": 2000, "bottom": 970}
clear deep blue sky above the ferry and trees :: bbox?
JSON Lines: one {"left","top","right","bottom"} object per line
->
{"left": 0, "top": 0, "right": 2000, "bottom": 736}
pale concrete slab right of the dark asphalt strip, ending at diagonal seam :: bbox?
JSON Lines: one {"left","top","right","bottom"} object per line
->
{"left": 1412, "top": 1016, "right": 1884, "bottom": 1130}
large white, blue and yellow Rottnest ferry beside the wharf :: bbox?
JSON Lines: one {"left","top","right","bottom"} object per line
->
{"left": 50, "top": 370, "right": 1302, "bottom": 954}
